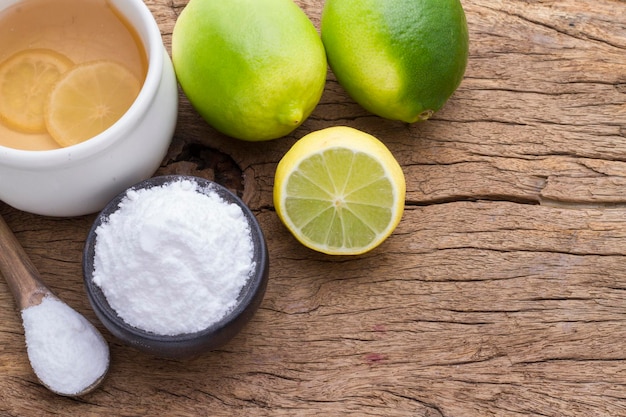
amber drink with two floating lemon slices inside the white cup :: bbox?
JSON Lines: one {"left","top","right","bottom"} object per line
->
{"left": 0, "top": 0, "right": 147, "bottom": 150}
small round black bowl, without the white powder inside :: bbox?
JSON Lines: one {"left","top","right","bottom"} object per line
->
{"left": 83, "top": 175, "right": 269, "bottom": 359}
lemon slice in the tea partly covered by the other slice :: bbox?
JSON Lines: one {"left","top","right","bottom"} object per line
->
{"left": 0, "top": 49, "right": 73, "bottom": 133}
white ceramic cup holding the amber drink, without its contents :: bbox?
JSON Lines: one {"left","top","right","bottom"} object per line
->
{"left": 0, "top": 0, "right": 178, "bottom": 217}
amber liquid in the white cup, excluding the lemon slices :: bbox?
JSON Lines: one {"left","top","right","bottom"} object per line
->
{"left": 0, "top": 0, "right": 148, "bottom": 150}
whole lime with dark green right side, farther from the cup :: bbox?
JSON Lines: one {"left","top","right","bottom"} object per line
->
{"left": 321, "top": 0, "right": 469, "bottom": 123}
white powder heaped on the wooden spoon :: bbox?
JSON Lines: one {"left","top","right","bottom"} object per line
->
{"left": 22, "top": 296, "right": 109, "bottom": 395}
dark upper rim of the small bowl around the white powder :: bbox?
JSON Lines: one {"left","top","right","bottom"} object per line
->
{"left": 82, "top": 174, "right": 269, "bottom": 346}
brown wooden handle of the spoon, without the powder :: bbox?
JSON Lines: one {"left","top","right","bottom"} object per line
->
{"left": 0, "top": 216, "right": 51, "bottom": 310}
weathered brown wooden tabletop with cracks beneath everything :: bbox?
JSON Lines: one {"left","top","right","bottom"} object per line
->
{"left": 0, "top": 0, "right": 626, "bottom": 417}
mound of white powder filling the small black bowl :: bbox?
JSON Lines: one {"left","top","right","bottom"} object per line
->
{"left": 93, "top": 180, "right": 254, "bottom": 335}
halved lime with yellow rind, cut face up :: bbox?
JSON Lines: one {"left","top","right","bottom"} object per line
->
{"left": 274, "top": 126, "right": 406, "bottom": 255}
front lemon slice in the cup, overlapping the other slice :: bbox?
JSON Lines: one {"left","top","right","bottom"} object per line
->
{"left": 45, "top": 60, "right": 141, "bottom": 146}
